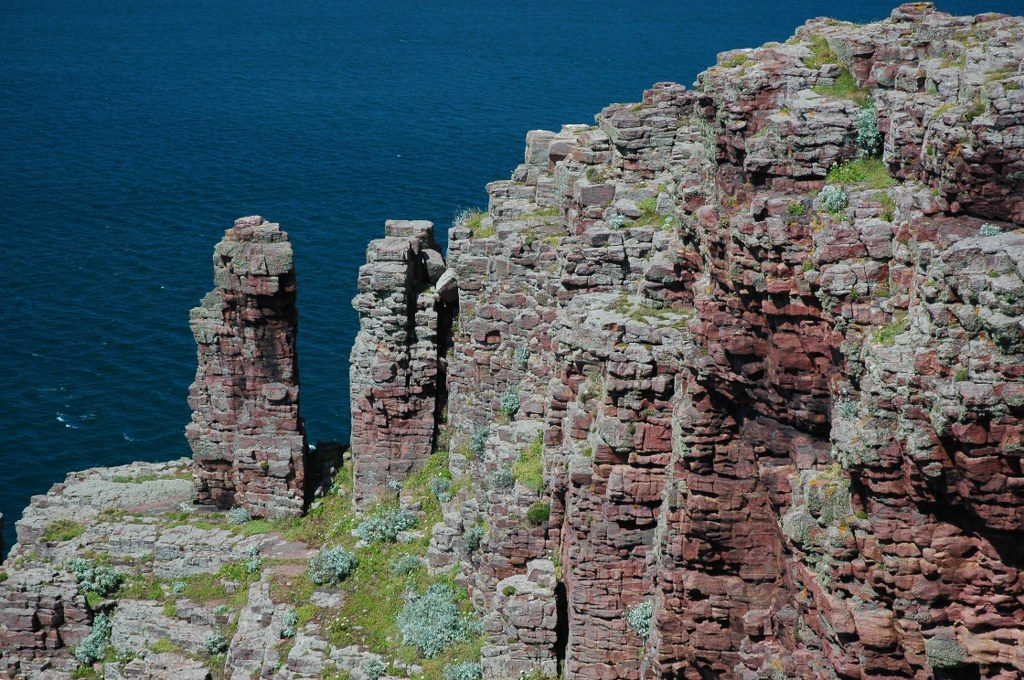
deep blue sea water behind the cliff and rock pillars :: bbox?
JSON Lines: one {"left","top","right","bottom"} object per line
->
{"left": 0, "top": 0, "right": 1022, "bottom": 547}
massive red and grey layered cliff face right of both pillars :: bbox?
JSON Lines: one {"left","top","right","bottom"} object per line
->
{"left": 353, "top": 3, "right": 1024, "bottom": 680}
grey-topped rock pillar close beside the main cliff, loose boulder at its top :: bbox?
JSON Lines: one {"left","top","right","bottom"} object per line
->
{"left": 349, "top": 220, "right": 455, "bottom": 507}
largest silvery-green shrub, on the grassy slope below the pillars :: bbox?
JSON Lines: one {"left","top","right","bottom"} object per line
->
{"left": 396, "top": 584, "right": 476, "bottom": 658}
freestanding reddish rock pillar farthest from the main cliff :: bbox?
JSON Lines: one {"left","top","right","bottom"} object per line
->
{"left": 185, "top": 216, "right": 309, "bottom": 517}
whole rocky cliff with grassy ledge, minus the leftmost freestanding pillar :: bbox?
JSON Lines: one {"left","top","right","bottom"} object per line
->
{"left": 0, "top": 3, "right": 1024, "bottom": 680}
